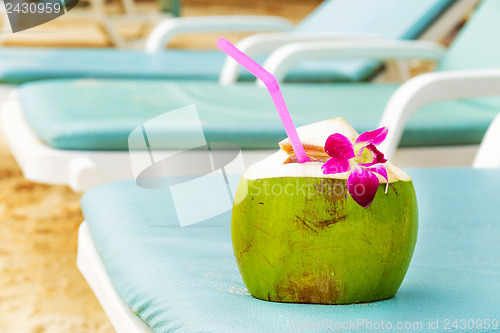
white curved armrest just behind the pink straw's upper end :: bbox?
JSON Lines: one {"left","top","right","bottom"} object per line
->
{"left": 219, "top": 32, "right": 380, "bottom": 85}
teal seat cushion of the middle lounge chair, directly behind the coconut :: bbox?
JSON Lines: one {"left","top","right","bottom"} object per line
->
{"left": 20, "top": 80, "right": 500, "bottom": 150}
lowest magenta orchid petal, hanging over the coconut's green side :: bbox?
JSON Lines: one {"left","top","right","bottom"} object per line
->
{"left": 347, "top": 167, "right": 379, "bottom": 208}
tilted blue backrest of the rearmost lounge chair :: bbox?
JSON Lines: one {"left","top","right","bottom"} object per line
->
{"left": 295, "top": 0, "right": 454, "bottom": 39}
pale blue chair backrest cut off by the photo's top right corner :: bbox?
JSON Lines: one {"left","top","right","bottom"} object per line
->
{"left": 438, "top": 0, "right": 500, "bottom": 70}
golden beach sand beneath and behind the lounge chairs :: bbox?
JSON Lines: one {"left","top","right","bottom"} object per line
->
{"left": 0, "top": 0, "right": 319, "bottom": 333}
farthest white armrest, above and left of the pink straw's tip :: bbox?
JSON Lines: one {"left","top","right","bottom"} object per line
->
{"left": 146, "top": 15, "right": 293, "bottom": 53}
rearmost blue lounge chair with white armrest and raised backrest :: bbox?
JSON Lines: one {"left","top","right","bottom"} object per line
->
{"left": 0, "top": 0, "right": 477, "bottom": 84}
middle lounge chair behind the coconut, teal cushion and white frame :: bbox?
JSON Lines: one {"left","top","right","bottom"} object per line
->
{"left": 2, "top": 0, "right": 500, "bottom": 190}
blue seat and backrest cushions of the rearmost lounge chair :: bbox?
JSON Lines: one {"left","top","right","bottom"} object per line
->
{"left": 0, "top": 0, "right": 453, "bottom": 83}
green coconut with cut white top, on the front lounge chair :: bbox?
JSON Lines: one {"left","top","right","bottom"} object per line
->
{"left": 231, "top": 118, "right": 418, "bottom": 304}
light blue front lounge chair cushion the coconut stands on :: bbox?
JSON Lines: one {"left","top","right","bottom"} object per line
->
{"left": 82, "top": 169, "right": 500, "bottom": 332}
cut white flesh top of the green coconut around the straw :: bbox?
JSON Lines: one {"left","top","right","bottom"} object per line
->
{"left": 243, "top": 118, "right": 411, "bottom": 184}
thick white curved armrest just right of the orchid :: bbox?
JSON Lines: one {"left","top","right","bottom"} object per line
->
{"left": 380, "top": 69, "right": 500, "bottom": 158}
